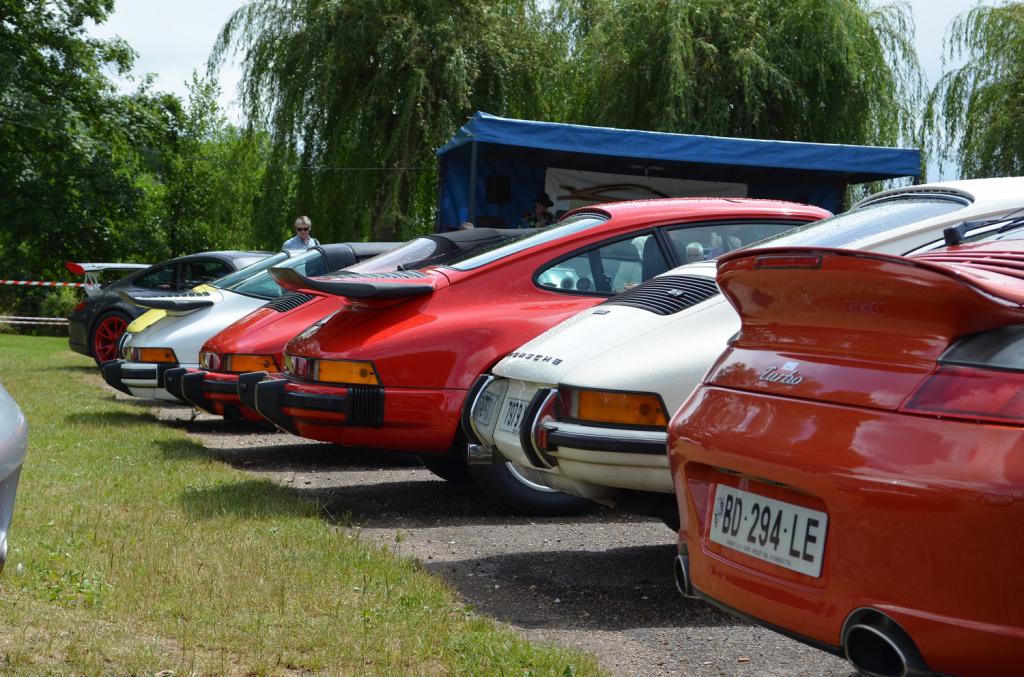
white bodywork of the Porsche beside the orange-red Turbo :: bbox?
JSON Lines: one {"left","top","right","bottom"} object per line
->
{"left": 480, "top": 178, "right": 1024, "bottom": 504}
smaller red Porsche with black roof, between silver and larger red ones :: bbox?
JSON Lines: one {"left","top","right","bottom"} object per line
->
{"left": 164, "top": 228, "right": 526, "bottom": 422}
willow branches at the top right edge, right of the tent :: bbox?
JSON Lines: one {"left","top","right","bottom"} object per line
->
{"left": 929, "top": 2, "right": 1024, "bottom": 177}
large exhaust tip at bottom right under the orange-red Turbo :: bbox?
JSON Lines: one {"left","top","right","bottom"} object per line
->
{"left": 843, "top": 609, "right": 934, "bottom": 677}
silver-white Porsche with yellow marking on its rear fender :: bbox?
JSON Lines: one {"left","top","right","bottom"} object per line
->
{"left": 100, "top": 243, "right": 401, "bottom": 401}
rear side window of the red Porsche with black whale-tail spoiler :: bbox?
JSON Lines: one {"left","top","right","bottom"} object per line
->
{"left": 537, "top": 234, "right": 668, "bottom": 294}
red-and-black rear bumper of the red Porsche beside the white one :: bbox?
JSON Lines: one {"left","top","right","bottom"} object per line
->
{"left": 247, "top": 374, "right": 466, "bottom": 453}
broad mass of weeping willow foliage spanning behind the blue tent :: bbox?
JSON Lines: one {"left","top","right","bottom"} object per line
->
{"left": 218, "top": 0, "right": 922, "bottom": 239}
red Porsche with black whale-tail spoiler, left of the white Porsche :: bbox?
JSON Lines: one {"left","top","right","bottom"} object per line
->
{"left": 243, "top": 199, "right": 827, "bottom": 503}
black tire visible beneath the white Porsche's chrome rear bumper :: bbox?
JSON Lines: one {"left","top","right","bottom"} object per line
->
{"left": 468, "top": 462, "right": 594, "bottom": 516}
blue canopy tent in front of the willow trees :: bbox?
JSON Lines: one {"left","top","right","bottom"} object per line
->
{"left": 437, "top": 113, "right": 921, "bottom": 229}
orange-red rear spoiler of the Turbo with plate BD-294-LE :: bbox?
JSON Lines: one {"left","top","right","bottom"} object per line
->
{"left": 718, "top": 243, "right": 1024, "bottom": 357}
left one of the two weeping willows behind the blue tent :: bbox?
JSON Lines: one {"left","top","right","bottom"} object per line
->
{"left": 211, "top": 0, "right": 556, "bottom": 241}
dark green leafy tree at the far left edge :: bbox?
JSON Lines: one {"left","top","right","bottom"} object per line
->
{"left": 0, "top": 0, "right": 146, "bottom": 276}
